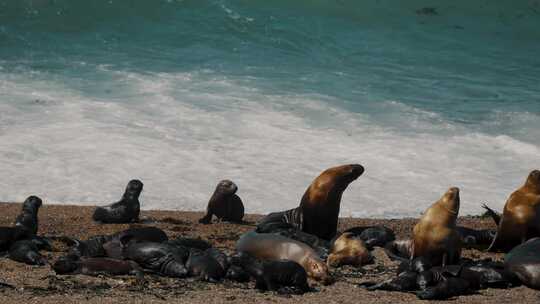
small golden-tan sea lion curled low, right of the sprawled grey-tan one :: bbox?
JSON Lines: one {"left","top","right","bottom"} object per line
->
{"left": 326, "top": 232, "right": 372, "bottom": 267}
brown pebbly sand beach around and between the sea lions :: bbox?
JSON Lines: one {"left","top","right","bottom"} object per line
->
{"left": 0, "top": 203, "right": 540, "bottom": 304}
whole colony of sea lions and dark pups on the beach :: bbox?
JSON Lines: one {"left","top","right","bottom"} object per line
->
{"left": 0, "top": 164, "right": 540, "bottom": 299}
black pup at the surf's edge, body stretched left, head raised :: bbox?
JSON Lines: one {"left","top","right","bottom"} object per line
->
{"left": 93, "top": 179, "right": 143, "bottom": 224}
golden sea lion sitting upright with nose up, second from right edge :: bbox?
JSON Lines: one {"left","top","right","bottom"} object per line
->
{"left": 411, "top": 187, "right": 461, "bottom": 266}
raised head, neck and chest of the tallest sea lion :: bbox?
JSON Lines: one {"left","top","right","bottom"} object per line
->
{"left": 299, "top": 164, "right": 364, "bottom": 240}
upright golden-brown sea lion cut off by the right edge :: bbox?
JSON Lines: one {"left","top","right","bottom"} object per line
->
{"left": 488, "top": 170, "right": 540, "bottom": 252}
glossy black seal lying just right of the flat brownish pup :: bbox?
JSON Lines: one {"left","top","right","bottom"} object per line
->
{"left": 123, "top": 242, "right": 189, "bottom": 278}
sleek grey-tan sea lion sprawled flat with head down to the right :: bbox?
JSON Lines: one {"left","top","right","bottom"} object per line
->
{"left": 236, "top": 231, "right": 333, "bottom": 284}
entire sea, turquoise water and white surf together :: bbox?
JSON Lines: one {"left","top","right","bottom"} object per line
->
{"left": 0, "top": 0, "right": 540, "bottom": 217}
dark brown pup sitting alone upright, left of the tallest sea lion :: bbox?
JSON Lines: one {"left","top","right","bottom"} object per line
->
{"left": 199, "top": 179, "right": 244, "bottom": 224}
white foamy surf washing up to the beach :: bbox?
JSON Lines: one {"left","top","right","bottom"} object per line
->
{"left": 0, "top": 67, "right": 540, "bottom": 217}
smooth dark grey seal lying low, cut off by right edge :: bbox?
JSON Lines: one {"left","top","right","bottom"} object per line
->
{"left": 504, "top": 237, "right": 540, "bottom": 290}
